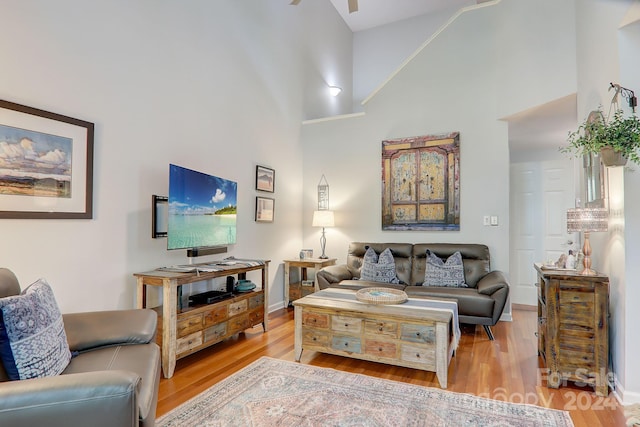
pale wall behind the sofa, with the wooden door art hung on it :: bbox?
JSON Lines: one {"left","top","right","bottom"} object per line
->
{"left": 302, "top": 0, "right": 575, "bottom": 326}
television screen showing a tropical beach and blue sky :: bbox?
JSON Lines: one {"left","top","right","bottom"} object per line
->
{"left": 167, "top": 164, "right": 238, "bottom": 249}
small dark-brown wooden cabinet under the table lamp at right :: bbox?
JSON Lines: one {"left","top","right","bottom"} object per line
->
{"left": 534, "top": 264, "right": 609, "bottom": 396}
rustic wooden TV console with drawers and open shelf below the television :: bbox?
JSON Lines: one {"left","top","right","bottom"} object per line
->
{"left": 134, "top": 260, "right": 269, "bottom": 378}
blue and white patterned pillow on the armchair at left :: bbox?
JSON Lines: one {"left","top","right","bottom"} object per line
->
{"left": 0, "top": 279, "right": 71, "bottom": 380}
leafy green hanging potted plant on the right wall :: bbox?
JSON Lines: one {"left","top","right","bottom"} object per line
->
{"left": 560, "top": 109, "right": 640, "bottom": 166}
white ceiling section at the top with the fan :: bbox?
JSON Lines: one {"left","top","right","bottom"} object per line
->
{"left": 331, "top": 0, "right": 475, "bottom": 33}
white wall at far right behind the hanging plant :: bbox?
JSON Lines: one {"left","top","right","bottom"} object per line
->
{"left": 576, "top": 0, "right": 640, "bottom": 403}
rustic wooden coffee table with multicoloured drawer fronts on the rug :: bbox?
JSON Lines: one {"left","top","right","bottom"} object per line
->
{"left": 293, "top": 288, "right": 460, "bottom": 388}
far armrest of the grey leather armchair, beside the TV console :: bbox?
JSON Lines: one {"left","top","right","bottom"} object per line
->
{"left": 62, "top": 309, "right": 158, "bottom": 351}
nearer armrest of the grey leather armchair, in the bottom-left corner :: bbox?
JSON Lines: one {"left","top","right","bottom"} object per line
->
{"left": 0, "top": 371, "right": 140, "bottom": 427}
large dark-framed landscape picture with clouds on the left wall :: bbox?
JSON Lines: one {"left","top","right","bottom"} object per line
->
{"left": 0, "top": 100, "right": 94, "bottom": 219}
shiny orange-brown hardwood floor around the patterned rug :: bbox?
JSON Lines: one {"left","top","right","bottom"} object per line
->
{"left": 157, "top": 308, "right": 625, "bottom": 427}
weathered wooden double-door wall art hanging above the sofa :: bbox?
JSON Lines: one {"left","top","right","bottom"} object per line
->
{"left": 382, "top": 132, "right": 460, "bottom": 231}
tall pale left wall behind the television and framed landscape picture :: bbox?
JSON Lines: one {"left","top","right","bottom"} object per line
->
{"left": 0, "top": 0, "right": 352, "bottom": 312}
